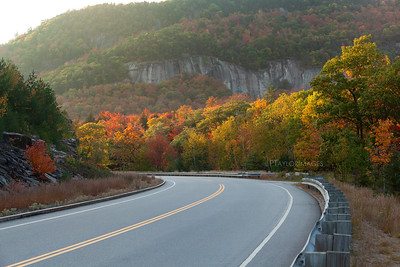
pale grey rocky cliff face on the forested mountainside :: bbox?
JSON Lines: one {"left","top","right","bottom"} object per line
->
{"left": 128, "top": 56, "right": 321, "bottom": 98}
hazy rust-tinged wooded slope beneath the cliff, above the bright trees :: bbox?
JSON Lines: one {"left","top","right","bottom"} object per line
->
{"left": 58, "top": 73, "right": 232, "bottom": 119}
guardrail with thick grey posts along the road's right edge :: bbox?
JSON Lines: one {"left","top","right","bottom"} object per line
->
{"left": 292, "top": 177, "right": 351, "bottom": 267}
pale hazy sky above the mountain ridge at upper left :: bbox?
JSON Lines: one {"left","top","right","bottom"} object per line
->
{"left": 0, "top": 0, "right": 162, "bottom": 44}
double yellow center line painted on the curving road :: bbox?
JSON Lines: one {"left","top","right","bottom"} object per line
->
{"left": 8, "top": 184, "right": 225, "bottom": 267}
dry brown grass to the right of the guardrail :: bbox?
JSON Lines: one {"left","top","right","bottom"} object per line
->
{"left": 331, "top": 180, "right": 400, "bottom": 266}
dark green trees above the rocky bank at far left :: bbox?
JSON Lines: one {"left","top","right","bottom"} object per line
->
{"left": 0, "top": 59, "right": 68, "bottom": 144}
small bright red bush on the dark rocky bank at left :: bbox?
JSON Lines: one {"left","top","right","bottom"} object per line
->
{"left": 25, "top": 141, "right": 57, "bottom": 180}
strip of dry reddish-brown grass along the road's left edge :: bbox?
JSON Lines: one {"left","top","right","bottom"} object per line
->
{"left": 0, "top": 173, "right": 162, "bottom": 216}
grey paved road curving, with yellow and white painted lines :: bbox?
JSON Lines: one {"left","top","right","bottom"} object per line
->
{"left": 0, "top": 177, "right": 320, "bottom": 266}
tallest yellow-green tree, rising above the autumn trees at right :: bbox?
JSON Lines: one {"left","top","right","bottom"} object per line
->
{"left": 311, "top": 36, "right": 389, "bottom": 140}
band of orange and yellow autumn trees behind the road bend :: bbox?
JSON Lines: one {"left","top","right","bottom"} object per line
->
{"left": 77, "top": 36, "right": 400, "bottom": 194}
